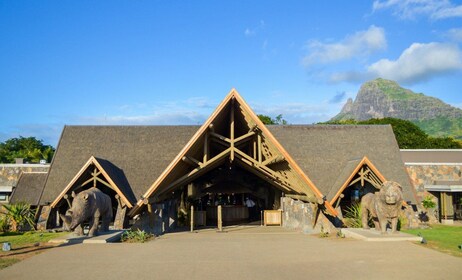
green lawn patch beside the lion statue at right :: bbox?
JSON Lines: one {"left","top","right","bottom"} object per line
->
{"left": 402, "top": 225, "right": 462, "bottom": 257}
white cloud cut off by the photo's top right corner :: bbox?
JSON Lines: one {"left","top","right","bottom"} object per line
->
{"left": 372, "top": 0, "right": 462, "bottom": 20}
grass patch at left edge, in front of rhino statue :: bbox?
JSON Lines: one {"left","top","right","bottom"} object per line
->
{"left": 0, "top": 231, "right": 69, "bottom": 270}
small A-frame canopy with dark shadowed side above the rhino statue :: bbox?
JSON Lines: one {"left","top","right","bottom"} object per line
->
{"left": 50, "top": 156, "right": 134, "bottom": 208}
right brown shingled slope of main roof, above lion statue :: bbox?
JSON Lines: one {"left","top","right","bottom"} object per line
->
{"left": 268, "top": 125, "right": 415, "bottom": 202}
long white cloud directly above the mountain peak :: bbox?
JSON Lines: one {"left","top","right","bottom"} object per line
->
{"left": 331, "top": 43, "right": 462, "bottom": 84}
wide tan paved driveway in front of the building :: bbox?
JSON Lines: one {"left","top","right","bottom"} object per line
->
{"left": 0, "top": 227, "right": 462, "bottom": 280}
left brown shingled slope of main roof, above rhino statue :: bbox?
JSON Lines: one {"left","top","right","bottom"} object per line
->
{"left": 40, "top": 126, "right": 198, "bottom": 204}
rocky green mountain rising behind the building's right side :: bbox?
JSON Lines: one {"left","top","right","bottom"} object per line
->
{"left": 331, "top": 78, "right": 462, "bottom": 139}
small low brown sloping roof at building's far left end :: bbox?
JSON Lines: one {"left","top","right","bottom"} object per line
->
{"left": 10, "top": 172, "right": 47, "bottom": 206}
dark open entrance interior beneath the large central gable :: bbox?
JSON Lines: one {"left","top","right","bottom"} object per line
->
{"left": 173, "top": 163, "right": 282, "bottom": 226}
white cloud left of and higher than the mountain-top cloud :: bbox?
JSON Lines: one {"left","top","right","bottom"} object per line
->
{"left": 303, "top": 25, "right": 387, "bottom": 66}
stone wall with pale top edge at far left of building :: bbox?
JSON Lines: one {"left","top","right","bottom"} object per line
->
{"left": 0, "top": 163, "right": 50, "bottom": 186}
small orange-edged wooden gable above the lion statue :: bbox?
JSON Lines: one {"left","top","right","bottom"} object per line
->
{"left": 328, "top": 157, "right": 386, "bottom": 205}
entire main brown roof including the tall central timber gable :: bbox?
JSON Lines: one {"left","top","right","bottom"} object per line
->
{"left": 40, "top": 92, "right": 415, "bottom": 214}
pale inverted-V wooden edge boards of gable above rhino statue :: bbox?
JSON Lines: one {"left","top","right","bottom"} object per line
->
{"left": 51, "top": 156, "right": 133, "bottom": 208}
